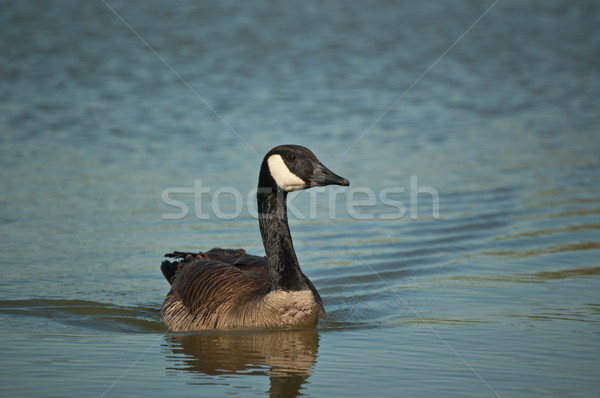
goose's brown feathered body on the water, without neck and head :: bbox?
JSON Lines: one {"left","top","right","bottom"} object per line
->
{"left": 161, "top": 249, "right": 325, "bottom": 331}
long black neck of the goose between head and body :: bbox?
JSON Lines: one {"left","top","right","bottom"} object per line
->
{"left": 257, "top": 181, "right": 308, "bottom": 291}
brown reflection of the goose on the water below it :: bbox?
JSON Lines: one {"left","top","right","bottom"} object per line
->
{"left": 167, "top": 329, "right": 319, "bottom": 397}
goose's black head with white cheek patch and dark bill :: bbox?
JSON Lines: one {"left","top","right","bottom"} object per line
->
{"left": 259, "top": 145, "right": 350, "bottom": 192}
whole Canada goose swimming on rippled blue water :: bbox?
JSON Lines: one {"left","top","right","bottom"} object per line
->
{"left": 160, "top": 145, "right": 350, "bottom": 332}
